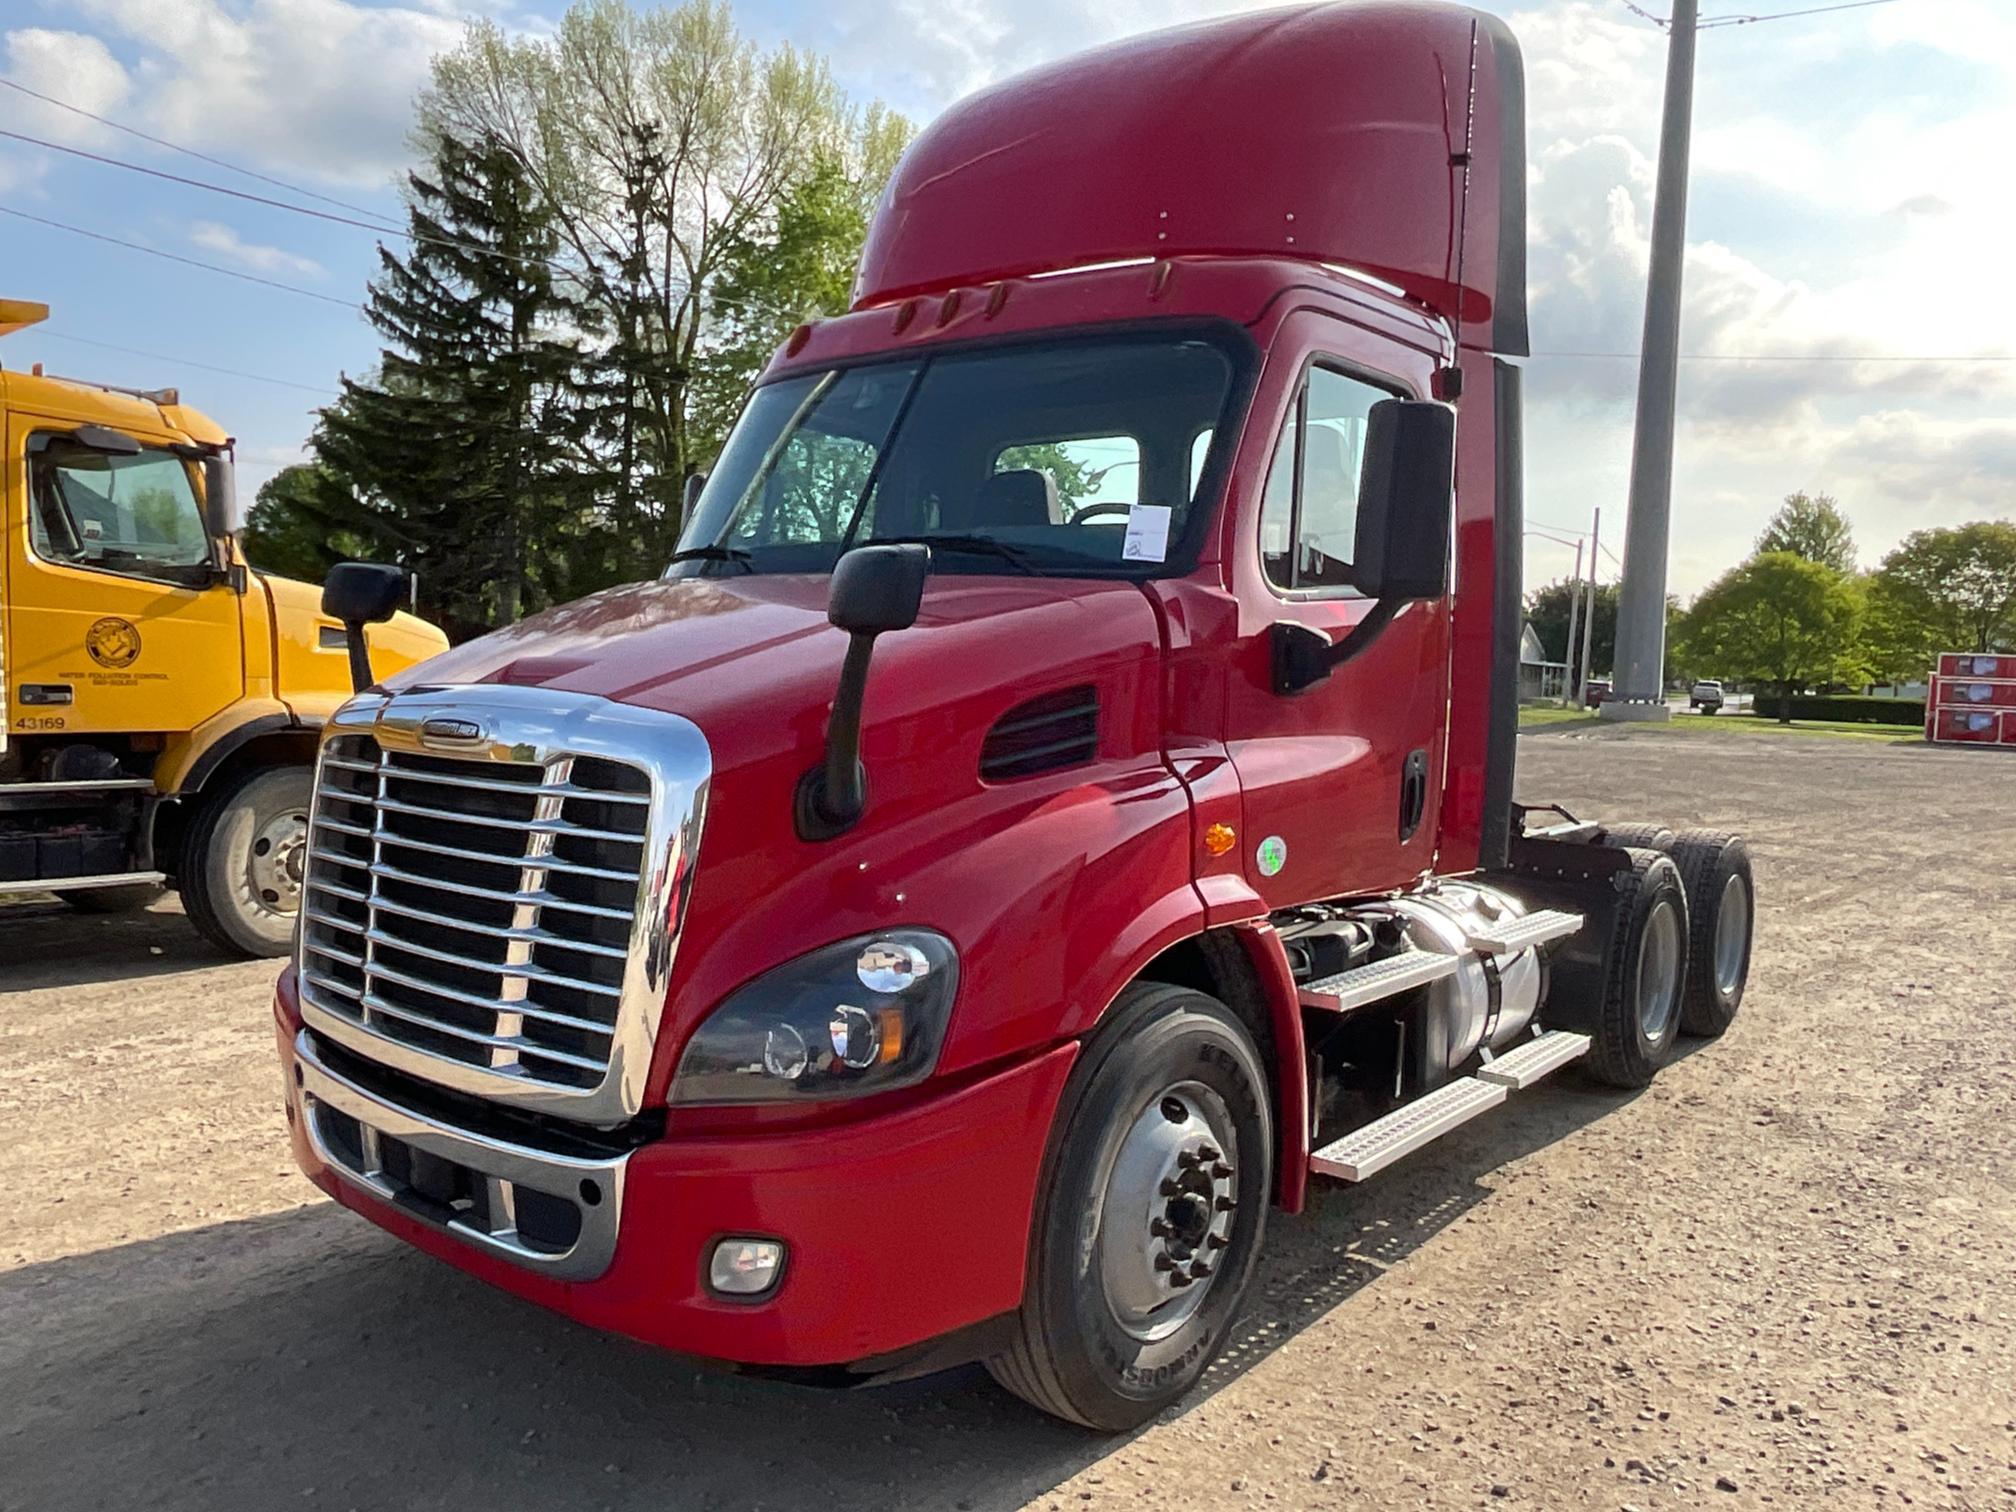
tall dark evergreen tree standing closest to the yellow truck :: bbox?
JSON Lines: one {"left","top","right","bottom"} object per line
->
{"left": 314, "top": 135, "right": 588, "bottom": 633}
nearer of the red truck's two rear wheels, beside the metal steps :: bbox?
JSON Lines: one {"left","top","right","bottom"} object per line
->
{"left": 1585, "top": 849, "right": 1689, "bottom": 1087}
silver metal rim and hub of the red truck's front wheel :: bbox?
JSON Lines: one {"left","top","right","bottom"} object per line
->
{"left": 1099, "top": 1083, "right": 1238, "bottom": 1341}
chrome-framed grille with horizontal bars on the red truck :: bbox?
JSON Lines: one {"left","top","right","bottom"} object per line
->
{"left": 298, "top": 687, "right": 706, "bottom": 1121}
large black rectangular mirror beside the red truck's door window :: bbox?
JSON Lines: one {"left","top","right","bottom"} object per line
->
{"left": 1351, "top": 399, "right": 1451, "bottom": 603}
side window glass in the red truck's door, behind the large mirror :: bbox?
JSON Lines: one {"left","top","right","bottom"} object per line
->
{"left": 1260, "top": 367, "right": 1393, "bottom": 593}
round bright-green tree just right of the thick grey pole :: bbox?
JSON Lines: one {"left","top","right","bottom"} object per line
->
{"left": 1679, "top": 550, "right": 1865, "bottom": 724}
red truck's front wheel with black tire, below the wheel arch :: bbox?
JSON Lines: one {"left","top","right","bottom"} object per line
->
{"left": 988, "top": 982, "right": 1274, "bottom": 1433}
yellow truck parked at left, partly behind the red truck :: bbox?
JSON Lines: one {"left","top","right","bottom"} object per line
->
{"left": 0, "top": 300, "right": 448, "bottom": 956}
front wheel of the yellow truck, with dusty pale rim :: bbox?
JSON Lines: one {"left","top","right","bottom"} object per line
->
{"left": 177, "top": 766, "right": 312, "bottom": 956}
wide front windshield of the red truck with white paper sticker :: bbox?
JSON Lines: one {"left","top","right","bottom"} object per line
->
{"left": 673, "top": 337, "right": 1234, "bottom": 575}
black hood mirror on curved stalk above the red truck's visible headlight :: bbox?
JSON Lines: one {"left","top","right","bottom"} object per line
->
{"left": 796, "top": 544, "right": 931, "bottom": 841}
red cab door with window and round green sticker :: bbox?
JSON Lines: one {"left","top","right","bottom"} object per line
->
{"left": 1226, "top": 312, "right": 1450, "bottom": 909}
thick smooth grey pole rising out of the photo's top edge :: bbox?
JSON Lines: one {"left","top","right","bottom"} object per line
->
{"left": 1601, "top": 0, "right": 1699, "bottom": 720}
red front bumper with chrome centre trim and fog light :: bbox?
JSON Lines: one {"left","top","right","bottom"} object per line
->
{"left": 274, "top": 980, "right": 1077, "bottom": 1367}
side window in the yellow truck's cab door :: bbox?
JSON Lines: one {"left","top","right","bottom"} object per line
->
{"left": 28, "top": 435, "right": 214, "bottom": 585}
